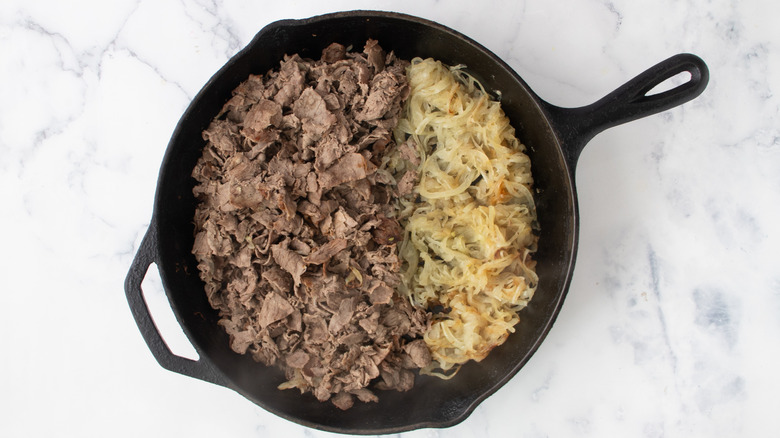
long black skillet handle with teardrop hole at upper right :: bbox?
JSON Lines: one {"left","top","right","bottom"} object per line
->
{"left": 544, "top": 53, "right": 709, "bottom": 173}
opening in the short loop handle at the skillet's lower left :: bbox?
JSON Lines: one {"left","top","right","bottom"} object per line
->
{"left": 141, "top": 263, "right": 200, "bottom": 361}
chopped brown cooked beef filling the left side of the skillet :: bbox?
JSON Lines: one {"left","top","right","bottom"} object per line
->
{"left": 192, "top": 40, "right": 431, "bottom": 409}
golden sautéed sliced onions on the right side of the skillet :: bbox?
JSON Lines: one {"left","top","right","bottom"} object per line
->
{"left": 391, "top": 58, "right": 537, "bottom": 377}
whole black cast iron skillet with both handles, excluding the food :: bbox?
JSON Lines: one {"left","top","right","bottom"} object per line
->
{"left": 125, "top": 11, "right": 708, "bottom": 434}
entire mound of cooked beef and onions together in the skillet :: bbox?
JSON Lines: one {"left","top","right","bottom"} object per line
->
{"left": 192, "top": 40, "right": 535, "bottom": 409}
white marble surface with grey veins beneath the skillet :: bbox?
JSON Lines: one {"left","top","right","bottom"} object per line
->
{"left": 0, "top": 0, "right": 780, "bottom": 438}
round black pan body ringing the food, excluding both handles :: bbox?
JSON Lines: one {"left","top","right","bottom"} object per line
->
{"left": 154, "top": 12, "right": 577, "bottom": 433}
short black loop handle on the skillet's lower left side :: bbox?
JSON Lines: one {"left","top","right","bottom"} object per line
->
{"left": 125, "top": 220, "right": 228, "bottom": 386}
